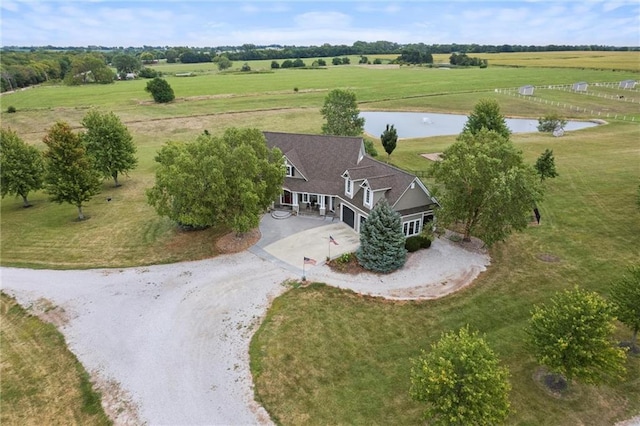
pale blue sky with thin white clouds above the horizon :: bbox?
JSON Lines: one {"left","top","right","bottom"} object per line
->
{"left": 0, "top": 0, "right": 640, "bottom": 47}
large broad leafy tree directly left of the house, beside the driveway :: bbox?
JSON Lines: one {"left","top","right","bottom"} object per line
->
{"left": 147, "top": 128, "right": 285, "bottom": 233}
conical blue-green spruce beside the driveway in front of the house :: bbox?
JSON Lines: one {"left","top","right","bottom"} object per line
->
{"left": 356, "top": 198, "right": 407, "bottom": 273}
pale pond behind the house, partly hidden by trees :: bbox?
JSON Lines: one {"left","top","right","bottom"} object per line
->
{"left": 360, "top": 111, "right": 597, "bottom": 138}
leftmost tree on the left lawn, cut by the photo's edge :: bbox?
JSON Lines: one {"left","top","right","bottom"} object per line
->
{"left": 0, "top": 129, "right": 44, "bottom": 207}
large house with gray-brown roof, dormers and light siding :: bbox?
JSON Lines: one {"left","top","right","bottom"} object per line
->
{"left": 264, "top": 132, "right": 438, "bottom": 236}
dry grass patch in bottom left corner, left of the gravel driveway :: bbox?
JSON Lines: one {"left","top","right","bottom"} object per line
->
{"left": 0, "top": 293, "right": 111, "bottom": 425}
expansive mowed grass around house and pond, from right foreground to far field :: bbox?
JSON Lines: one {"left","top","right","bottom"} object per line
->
{"left": 0, "top": 52, "right": 640, "bottom": 425}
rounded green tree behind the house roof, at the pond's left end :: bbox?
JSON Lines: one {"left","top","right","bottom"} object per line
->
{"left": 320, "top": 89, "right": 364, "bottom": 136}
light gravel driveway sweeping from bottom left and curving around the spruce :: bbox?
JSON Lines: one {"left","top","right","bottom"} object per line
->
{"left": 0, "top": 219, "right": 489, "bottom": 425}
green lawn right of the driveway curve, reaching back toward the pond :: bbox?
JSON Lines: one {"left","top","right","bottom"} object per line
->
{"left": 251, "top": 120, "right": 640, "bottom": 425}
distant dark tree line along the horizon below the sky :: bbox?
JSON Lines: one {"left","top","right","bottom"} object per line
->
{"left": 0, "top": 41, "right": 640, "bottom": 92}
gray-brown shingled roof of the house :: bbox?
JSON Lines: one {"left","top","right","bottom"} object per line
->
{"left": 264, "top": 132, "right": 432, "bottom": 205}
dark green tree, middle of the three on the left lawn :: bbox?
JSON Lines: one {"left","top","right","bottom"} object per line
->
{"left": 43, "top": 122, "right": 101, "bottom": 220}
